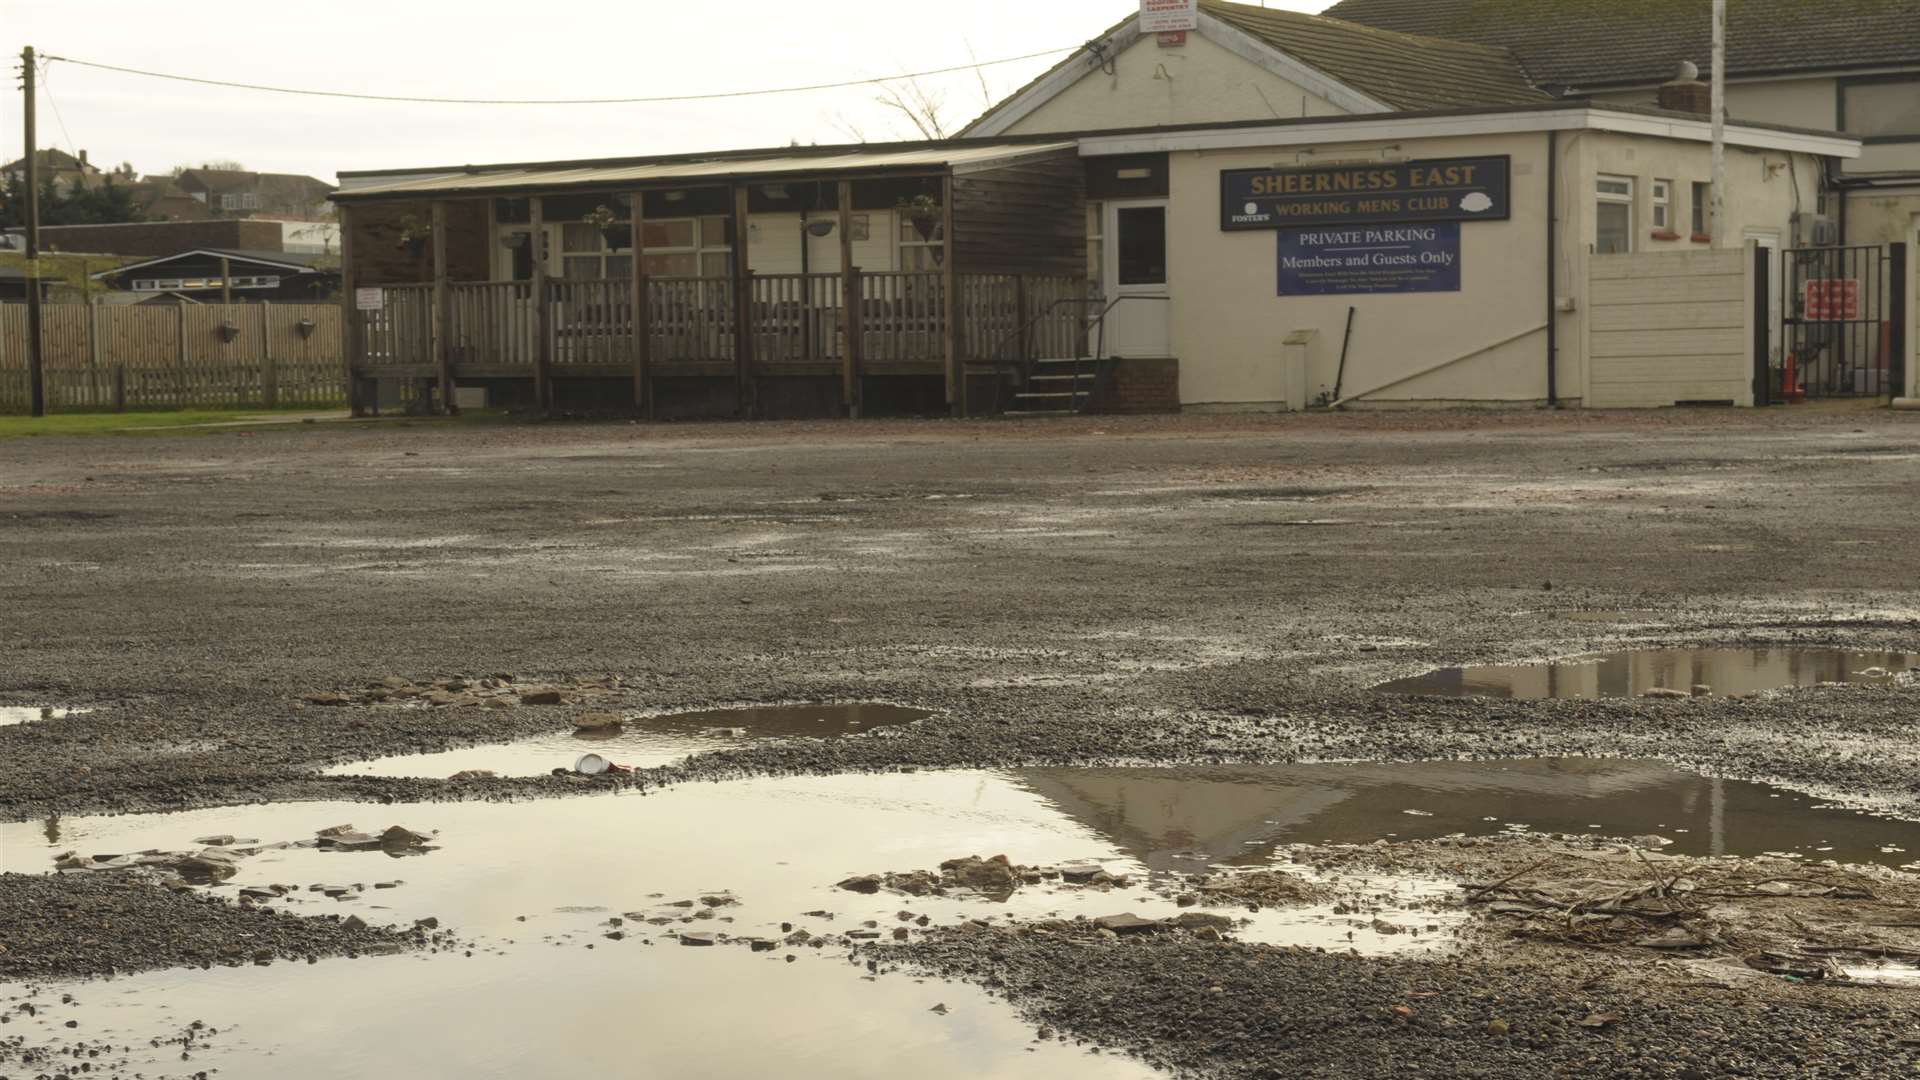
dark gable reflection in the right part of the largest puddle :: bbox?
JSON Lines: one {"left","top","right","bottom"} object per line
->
{"left": 1016, "top": 757, "right": 1920, "bottom": 869}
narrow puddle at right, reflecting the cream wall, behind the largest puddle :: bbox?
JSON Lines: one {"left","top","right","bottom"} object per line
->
{"left": 1375, "top": 648, "right": 1914, "bottom": 698}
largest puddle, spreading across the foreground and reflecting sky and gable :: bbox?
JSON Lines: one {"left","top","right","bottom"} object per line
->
{"left": 15, "top": 759, "right": 1920, "bottom": 1080}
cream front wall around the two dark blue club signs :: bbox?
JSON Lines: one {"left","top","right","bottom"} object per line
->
{"left": 1167, "top": 135, "right": 1578, "bottom": 407}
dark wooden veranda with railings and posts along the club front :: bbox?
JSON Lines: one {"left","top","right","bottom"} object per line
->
{"left": 338, "top": 136, "right": 1087, "bottom": 417}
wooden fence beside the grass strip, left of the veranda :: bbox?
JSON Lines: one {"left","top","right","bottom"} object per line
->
{"left": 0, "top": 304, "right": 346, "bottom": 411}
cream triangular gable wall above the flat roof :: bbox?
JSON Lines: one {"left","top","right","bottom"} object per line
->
{"left": 1008, "top": 33, "right": 1346, "bottom": 135}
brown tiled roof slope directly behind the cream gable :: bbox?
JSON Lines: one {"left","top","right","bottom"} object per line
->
{"left": 1200, "top": 0, "right": 1546, "bottom": 110}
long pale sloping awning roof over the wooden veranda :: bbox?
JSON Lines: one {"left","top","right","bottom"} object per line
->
{"left": 332, "top": 142, "right": 1077, "bottom": 202}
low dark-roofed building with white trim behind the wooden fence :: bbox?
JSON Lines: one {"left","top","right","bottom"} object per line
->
{"left": 94, "top": 248, "right": 340, "bottom": 304}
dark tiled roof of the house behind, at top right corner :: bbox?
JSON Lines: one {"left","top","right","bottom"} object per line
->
{"left": 1327, "top": 0, "right": 1920, "bottom": 86}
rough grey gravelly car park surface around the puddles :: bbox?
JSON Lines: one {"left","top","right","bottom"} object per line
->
{"left": 0, "top": 407, "right": 1920, "bottom": 1076}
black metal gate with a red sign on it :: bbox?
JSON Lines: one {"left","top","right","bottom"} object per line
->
{"left": 1768, "top": 244, "right": 1907, "bottom": 402}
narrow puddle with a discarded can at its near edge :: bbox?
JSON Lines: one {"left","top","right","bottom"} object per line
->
{"left": 326, "top": 703, "right": 931, "bottom": 778}
